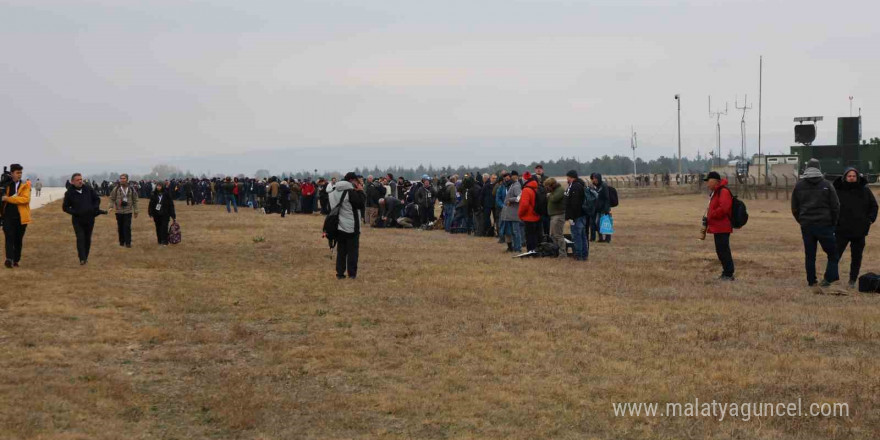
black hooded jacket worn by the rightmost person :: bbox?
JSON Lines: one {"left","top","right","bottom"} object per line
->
{"left": 834, "top": 168, "right": 877, "bottom": 237}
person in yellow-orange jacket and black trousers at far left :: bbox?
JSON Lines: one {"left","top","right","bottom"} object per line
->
{"left": 0, "top": 163, "right": 31, "bottom": 269}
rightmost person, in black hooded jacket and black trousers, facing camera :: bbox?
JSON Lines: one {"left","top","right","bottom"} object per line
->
{"left": 834, "top": 167, "right": 877, "bottom": 287}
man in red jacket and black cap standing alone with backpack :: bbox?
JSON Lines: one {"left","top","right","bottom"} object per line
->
{"left": 703, "top": 171, "right": 734, "bottom": 281}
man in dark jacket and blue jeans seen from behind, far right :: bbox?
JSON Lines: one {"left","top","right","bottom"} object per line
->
{"left": 791, "top": 159, "right": 840, "bottom": 293}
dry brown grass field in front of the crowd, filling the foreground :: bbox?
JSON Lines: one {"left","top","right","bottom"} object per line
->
{"left": 0, "top": 195, "right": 880, "bottom": 439}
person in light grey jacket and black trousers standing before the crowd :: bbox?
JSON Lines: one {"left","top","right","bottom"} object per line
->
{"left": 329, "top": 172, "right": 366, "bottom": 280}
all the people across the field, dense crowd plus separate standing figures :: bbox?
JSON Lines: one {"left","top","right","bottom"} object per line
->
{"left": 0, "top": 159, "right": 878, "bottom": 294}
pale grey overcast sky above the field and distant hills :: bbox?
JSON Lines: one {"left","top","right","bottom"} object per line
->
{"left": 0, "top": 0, "right": 880, "bottom": 172}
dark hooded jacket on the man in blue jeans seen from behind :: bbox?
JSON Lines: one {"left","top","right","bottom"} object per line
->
{"left": 791, "top": 160, "right": 840, "bottom": 226}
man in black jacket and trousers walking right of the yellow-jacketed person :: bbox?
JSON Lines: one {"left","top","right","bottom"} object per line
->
{"left": 61, "top": 173, "right": 101, "bottom": 265}
